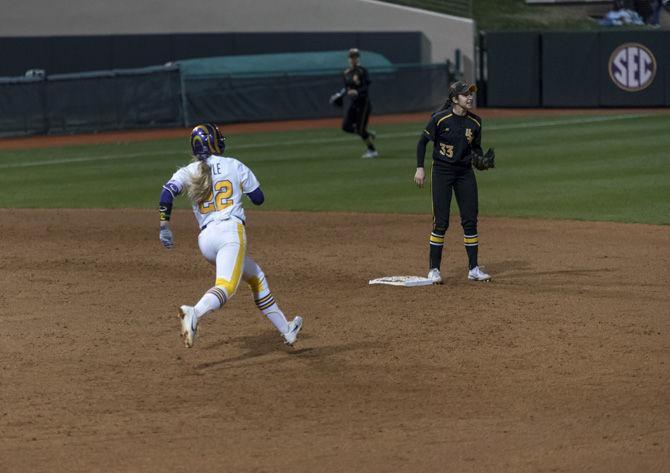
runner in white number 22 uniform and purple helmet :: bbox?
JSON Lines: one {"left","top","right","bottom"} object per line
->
{"left": 159, "top": 123, "right": 302, "bottom": 348}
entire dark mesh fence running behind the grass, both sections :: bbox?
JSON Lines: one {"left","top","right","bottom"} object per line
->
{"left": 0, "top": 64, "right": 451, "bottom": 137}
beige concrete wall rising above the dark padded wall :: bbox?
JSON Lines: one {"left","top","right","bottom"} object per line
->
{"left": 0, "top": 0, "right": 475, "bottom": 78}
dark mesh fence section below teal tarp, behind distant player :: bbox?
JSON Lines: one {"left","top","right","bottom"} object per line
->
{"left": 182, "top": 64, "right": 450, "bottom": 125}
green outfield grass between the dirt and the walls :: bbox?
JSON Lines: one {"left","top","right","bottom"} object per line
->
{"left": 0, "top": 112, "right": 670, "bottom": 224}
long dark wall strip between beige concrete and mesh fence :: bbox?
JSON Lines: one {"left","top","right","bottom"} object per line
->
{"left": 0, "top": 31, "right": 430, "bottom": 77}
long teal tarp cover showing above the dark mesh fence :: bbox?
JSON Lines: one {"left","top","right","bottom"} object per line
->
{"left": 176, "top": 51, "right": 394, "bottom": 78}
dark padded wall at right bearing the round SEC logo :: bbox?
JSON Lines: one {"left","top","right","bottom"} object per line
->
{"left": 483, "top": 30, "right": 670, "bottom": 107}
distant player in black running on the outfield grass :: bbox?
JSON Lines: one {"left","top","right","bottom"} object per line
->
{"left": 342, "top": 48, "right": 379, "bottom": 158}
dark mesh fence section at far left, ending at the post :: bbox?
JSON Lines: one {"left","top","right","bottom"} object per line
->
{"left": 0, "top": 66, "right": 184, "bottom": 136}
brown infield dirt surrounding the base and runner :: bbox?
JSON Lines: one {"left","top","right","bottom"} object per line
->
{"left": 0, "top": 210, "right": 670, "bottom": 473}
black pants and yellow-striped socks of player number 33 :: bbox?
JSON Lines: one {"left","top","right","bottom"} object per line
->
{"left": 429, "top": 164, "right": 479, "bottom": 269}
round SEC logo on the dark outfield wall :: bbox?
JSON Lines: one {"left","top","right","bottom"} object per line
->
{"left": 609, "top": 43, "right": 657, "bottom": 92}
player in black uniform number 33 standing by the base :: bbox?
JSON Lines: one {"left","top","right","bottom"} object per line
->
{"left": 414, "top": 82, "right": 491, "bottom": 284}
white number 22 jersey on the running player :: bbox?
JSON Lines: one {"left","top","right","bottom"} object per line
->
{"left": 168, "top": 155, "right": 260, "bottom": 228}
